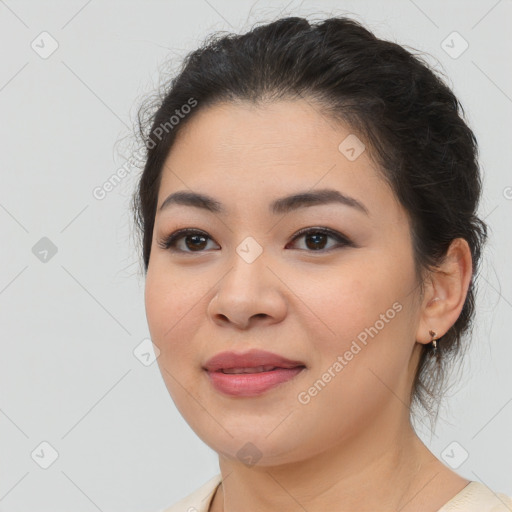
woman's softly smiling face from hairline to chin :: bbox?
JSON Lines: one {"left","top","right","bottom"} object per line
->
{"left": 145, "top": 100, "right": 421, "bottom": 465}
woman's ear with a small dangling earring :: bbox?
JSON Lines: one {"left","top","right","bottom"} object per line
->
{"left": 416, "top": 238, "right": 473, "bottom": 344}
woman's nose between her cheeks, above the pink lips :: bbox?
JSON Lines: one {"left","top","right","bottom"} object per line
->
{"left": 208, "top": 250, "right": 287, "bottom": 330}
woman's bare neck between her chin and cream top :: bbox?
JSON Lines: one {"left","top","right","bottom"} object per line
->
{"left": 210, "top": 407, "right": 444, "bottom": 512}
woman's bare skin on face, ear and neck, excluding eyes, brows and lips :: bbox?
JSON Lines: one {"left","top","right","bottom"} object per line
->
{"left": 145, "top": 99, "right": 471, "bottom": 512}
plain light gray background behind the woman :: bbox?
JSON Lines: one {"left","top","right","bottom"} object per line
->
{"left": 0, "top": 0, "right": 512, "bottom": 512}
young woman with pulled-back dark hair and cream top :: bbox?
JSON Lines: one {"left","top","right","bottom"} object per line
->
{"left": 134, "top": 17, "right": 512, "bottom": 512}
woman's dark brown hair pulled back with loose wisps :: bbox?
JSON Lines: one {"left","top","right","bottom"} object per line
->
{"left": 133, "top": 17, "right": 487, "bottom": 428}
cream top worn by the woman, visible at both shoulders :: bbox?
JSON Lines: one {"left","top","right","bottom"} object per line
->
{"left": 158, "top": 473, "right": 512, "bottom": 512}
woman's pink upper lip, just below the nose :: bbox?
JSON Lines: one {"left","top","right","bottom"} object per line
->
{"left": 203, "top": 349, "right": 306, "bottom": 373}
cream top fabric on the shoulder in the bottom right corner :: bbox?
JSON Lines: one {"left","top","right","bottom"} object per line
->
{"left": 438, "top": 481, "right": 512, "bottom": 512}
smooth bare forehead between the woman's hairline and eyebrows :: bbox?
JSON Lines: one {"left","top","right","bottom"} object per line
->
{"left": 158, "top": 100, "right": 395, "bottom": 221}
